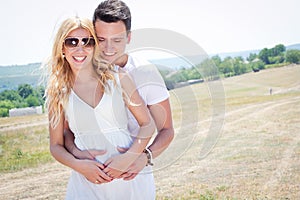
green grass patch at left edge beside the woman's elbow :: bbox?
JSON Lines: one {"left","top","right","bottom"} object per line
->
{"left": 0, "top": 121, "right": 53, "bottom": 172}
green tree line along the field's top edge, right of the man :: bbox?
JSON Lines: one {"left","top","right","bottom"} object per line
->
{"left": 160, "top": 44, "right": 300, "bottom": 89}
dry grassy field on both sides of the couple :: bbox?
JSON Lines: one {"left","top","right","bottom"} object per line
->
{"left": 0, "top": 65, "right": 300, "bottom": 200}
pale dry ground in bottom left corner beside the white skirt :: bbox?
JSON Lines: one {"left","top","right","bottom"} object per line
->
{"left": 0, "top": 162, "right": 70, "bottom": 200}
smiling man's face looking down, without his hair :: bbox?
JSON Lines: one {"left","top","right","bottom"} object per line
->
{"left": 95, "top": 20, "right": 130, "bottom": 64}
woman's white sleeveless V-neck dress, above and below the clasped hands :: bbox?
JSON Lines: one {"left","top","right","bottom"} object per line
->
{"left": 65, "top": 75, "right": 155, "bottom": 200}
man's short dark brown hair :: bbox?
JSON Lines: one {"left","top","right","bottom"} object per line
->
{"left": 93, "top": 0, "right": 131, "bottom": 32}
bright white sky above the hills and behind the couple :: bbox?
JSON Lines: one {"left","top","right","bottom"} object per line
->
{"left": 0, "top": 0, "right": 300, "bottom": 66}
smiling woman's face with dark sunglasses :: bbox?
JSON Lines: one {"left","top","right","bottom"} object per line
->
{"left": 63, "top": 28, "right": 95, "bottom": 72}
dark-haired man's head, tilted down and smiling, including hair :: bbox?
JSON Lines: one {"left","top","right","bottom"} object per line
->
{"left": 93, "top": 0, "right": 131, "bottom": 66}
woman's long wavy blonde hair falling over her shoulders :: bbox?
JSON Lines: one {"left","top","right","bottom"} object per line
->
{"left": 45, "top": 17, "right": 115, "bottom": 128}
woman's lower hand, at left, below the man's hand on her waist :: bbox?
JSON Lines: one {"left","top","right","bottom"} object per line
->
{"left": 77, "top": 160, "right": 113, "bottom": 184}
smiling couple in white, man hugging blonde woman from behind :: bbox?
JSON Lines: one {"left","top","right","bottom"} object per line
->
{"left": 46, "top": 0, "right": 174, "bottom": 199}
